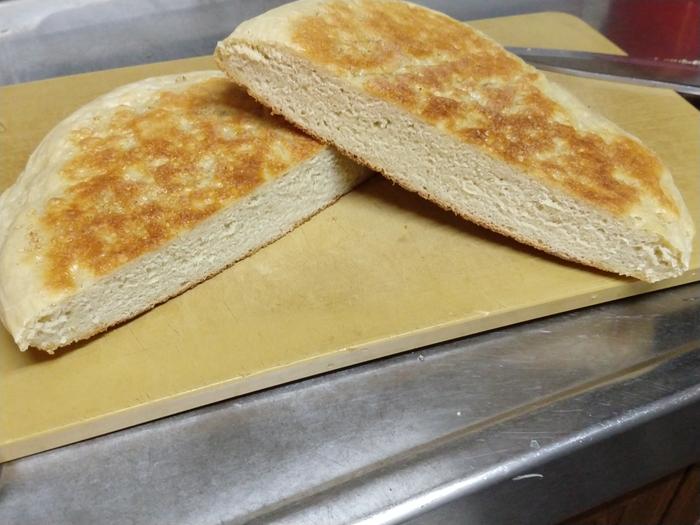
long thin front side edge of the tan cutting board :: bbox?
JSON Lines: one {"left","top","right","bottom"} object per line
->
{"left": 0, "top": 271, "right": 700, "bottom": 463}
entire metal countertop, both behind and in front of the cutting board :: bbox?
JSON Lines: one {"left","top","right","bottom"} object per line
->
{"left": 0, "top": 0, "right": 700, "bottom": 524}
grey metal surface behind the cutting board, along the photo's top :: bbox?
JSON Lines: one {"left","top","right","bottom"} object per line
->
{"left": 0, "top": 0, "right": 605, "bottom": 85}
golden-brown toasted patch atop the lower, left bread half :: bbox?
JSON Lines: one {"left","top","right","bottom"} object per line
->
{"left": 37, "top": 78, "right": 322, "bottom": 290}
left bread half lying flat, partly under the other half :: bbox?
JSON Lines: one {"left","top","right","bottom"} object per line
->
{"left": 0, "top": 71, "right": 368, "bottom": 351}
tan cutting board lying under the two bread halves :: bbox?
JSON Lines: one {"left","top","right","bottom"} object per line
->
{"left": 0, "top": 13, "right": 700, "bottom": 461}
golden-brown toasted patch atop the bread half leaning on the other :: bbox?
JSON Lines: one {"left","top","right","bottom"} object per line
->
{"left": 290, "top": 0, "right": 679, "bottom": 217}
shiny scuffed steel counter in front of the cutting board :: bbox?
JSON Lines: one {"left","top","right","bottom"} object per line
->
{"left": 0, "top": 284, "right": 700, "bottom": 523}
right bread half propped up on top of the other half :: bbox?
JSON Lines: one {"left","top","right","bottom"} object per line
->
{"left": 216, "top": 0, "right": 694, "bottom": 282}
